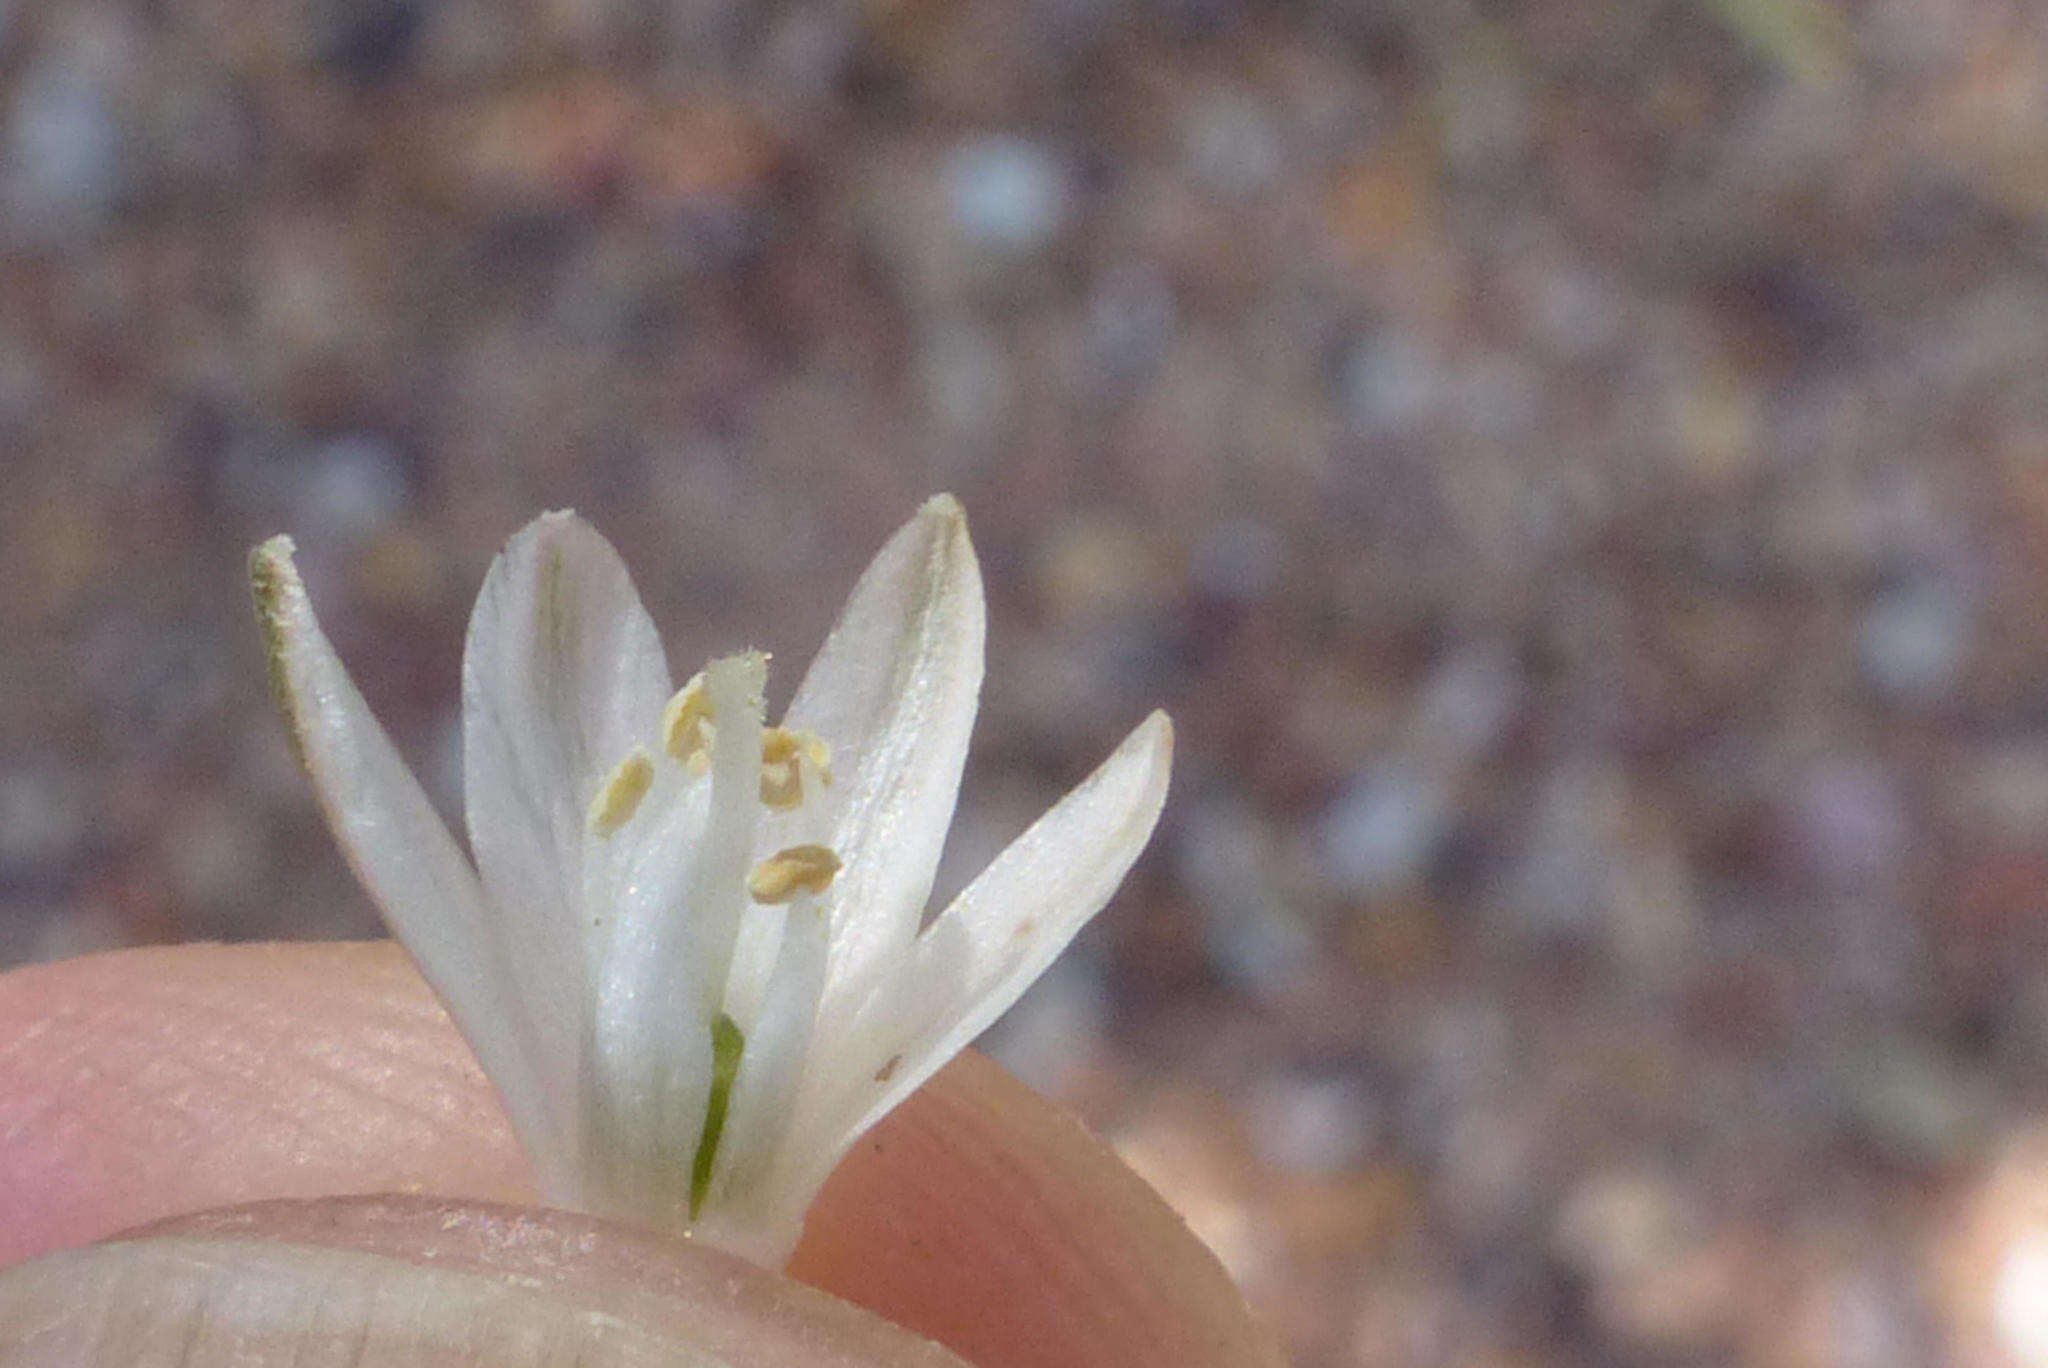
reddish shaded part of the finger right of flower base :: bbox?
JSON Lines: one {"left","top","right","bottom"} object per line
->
{"left": 791, "top": 1051, "right": 1280, "bottom": 1368}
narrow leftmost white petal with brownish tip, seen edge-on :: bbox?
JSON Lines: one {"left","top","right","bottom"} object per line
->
{"left": 250, "top": 537, "right": 582, "bottom": 1178}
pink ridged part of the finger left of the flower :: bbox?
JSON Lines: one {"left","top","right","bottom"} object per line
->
{"left": 0, "top": 942, "right": 532, "bottom": 1266}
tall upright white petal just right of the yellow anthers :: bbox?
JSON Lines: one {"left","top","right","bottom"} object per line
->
{"left": 778, "top": 496, "right": 985, "bottom": 1010}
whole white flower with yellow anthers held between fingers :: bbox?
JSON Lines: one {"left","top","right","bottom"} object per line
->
{"left": 250, "top": 496, "right": 1171, "bottom": 1266}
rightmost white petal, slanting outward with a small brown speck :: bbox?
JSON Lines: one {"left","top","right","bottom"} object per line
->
{"left": 852, "top": 713, "right": 1174, "bottom": 1137}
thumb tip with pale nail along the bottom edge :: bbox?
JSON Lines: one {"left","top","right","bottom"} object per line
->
{"left": 0, "top": 1196, "right": 967, "bottom": 1368}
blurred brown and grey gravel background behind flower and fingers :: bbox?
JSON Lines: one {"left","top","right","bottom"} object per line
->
{"left": 0, "top": 0, "right": 2048, "bottom": 1368}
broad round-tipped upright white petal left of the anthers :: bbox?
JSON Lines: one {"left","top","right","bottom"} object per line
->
{"left": 463, "top": 512, "right": 668, "bottom": 1073}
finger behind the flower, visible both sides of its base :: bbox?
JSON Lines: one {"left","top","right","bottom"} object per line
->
{"left": 0, "top": 944, "right": 1278, "bottom": 1368}
